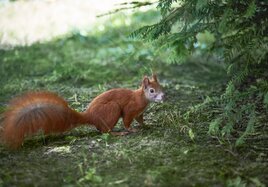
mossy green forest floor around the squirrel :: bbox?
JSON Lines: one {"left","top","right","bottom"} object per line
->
{"left": 0, "top": 1, "right": 268, "bottom": 186}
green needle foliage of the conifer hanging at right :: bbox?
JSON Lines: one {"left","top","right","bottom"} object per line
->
{"left": 132, "top": 0, "right": 268, "bottom": 145}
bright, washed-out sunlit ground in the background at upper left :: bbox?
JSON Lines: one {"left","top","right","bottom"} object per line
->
{"left": 0, "top": 0, "right": 140, "bottom": 48}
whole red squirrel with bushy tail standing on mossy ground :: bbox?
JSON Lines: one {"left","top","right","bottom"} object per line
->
{"left": 0, "top": 74, "right": 164, "bottom": 148}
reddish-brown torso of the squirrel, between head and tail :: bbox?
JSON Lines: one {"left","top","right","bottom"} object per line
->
{"left": 84, "top": 88, "right": 149, "bottom": 132}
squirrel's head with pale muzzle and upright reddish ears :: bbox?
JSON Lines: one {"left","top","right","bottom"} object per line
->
{"left": 142, "top": 74, "right": 165, "bottom": 102}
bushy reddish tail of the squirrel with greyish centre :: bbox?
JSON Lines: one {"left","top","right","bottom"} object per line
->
{"left": 0, "top": 92, "right": 84, "bottom": 148}
